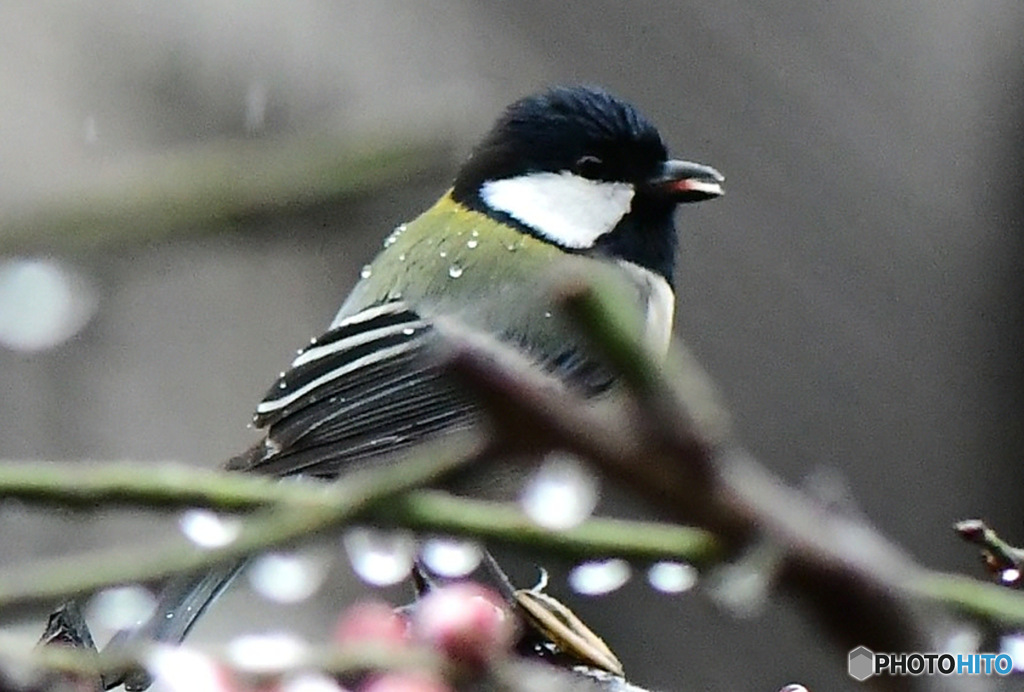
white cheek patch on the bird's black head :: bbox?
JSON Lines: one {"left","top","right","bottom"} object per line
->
{"left": 480, "top": 171, "right": 635, "bottom": 250}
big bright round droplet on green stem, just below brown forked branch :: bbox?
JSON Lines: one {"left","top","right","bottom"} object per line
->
{"left": 520, "top": 455, "right": 600, "bottom": 531}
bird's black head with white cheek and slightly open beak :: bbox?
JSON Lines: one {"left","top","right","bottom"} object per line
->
{"left": 453, "top": 87, "right": 724, "bottom": 284}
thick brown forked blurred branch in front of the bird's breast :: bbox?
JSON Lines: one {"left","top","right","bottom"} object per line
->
{"left": 447, "top": 278, "right": 999, "bottom": 689}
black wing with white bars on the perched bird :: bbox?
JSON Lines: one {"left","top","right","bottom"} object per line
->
{"left": 228, "top": 301, "right": 477, "bottom": 477}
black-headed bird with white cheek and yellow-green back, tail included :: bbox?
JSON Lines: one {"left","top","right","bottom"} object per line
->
{"left": 112, "top": 85, "right": 724, "bottom": 689}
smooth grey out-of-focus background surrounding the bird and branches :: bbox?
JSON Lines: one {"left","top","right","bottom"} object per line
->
{"left": 0, "top": 0, "right": 1024, "bottom": 692}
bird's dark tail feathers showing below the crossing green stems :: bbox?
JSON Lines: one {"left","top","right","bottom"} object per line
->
{"left": 103, "top": 561, "right": 246, "bottom": 692}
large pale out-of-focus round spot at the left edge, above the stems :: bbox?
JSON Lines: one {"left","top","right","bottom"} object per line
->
{"left": 0, "top": 259, "right": 98, "bottom": 351}
